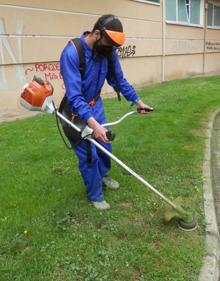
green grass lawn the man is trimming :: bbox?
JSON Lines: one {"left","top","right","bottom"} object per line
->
{"left": 0, "top": 76, "right": 220, "bottom": 281}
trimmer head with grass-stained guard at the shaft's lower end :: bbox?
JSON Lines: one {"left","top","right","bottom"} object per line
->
{"left": 164, "top": 197, "right": 197, "bottom": 231}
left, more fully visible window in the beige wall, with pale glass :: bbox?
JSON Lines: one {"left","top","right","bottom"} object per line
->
{"left": 166, "top": 0, "right": 202, "bottom": 25}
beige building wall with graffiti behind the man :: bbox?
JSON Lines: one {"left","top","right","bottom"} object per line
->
{"left": 0, "top": 0, "right": 220, "bottom": 116}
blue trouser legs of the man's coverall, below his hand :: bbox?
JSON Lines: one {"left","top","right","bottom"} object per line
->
{"left": 74, "top": 138, "right": 112, "bottom": 202}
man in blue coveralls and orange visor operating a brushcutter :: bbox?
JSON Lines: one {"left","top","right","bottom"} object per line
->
{"left": 60, "top": 15, "right": 152, "bottom": 210}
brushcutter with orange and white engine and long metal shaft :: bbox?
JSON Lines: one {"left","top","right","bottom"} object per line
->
{"left": 20, "top": 77, "right": 197, "bottom": 231}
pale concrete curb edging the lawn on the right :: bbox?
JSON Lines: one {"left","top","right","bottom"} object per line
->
{"left": 198, "top": 110, "right": 220, "bottom": 281}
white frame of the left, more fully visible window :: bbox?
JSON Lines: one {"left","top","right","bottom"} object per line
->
{"left": 166, "top": 0, "right": 205, "bottom": 28}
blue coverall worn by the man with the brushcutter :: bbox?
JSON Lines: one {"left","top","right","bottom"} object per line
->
{"left": 60, "top": 32, "right": 139, "bottom": 202}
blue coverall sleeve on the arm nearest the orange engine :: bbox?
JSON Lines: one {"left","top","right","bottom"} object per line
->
{"left": 60, "top": 43, "right": 92, "bottom": 122}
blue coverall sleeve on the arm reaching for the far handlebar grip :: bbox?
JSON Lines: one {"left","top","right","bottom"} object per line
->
{"left": 106, "top": 50, "right": 140, "bottom": 103}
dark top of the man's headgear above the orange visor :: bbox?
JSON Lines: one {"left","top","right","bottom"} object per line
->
{"left": 92, "top": 14, "right": 123, "bottom": 32}
